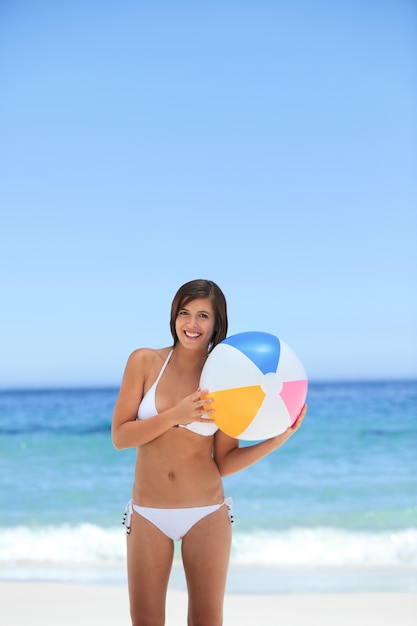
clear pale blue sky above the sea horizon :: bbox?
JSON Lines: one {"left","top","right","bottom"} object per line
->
{"left": 0, "top": 0, "right": 417, "bottom": 389}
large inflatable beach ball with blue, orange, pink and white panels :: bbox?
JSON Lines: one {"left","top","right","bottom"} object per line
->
{"left": 200, "top": 331, "right": 308, "bottom": 441}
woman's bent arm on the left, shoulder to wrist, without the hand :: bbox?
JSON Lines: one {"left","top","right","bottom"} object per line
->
{"left": 111, "top": 349, "right": 178, "bottom": 450}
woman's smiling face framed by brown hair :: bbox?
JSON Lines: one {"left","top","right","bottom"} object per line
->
{"left": 175, "top": 298, "right": 216, "bottom": 350}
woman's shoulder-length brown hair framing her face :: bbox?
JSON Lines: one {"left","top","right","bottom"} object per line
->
{"left": 170, "top": 278, "right": 228, "bottom": 352}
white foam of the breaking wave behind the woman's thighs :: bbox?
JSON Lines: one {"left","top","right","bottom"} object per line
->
{"left": 0, "top": 524, "right": 417, "bottom": 569}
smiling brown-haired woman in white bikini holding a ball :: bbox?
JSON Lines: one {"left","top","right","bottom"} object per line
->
{"left": 112, "top": 280, "right": 305, "bottom": 626}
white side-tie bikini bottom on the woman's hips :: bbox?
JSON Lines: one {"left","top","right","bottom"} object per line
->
{"left": 122, "top": 498, "right": 233, "bottom": 541}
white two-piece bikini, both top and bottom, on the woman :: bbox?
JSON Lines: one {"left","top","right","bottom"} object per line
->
{"left": 122, "top": 350, "right": 233, "bottom": 541}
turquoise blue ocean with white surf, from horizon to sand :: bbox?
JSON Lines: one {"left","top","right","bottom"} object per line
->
{"left": 0, "top": 381, "right": 417, "bottom": 594}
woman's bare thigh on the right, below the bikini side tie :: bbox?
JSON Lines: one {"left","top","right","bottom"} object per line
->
{"left": 182, "top": 506, "right": 232, "bottom": 626}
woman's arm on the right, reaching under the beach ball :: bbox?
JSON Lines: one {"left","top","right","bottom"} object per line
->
{"left": 214, "top": 404, "right": 307, "bottom": 476}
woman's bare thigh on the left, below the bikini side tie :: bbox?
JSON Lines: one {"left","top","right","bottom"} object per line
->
{"left": 127, "top": 513, "right": 174, "bottom": 626}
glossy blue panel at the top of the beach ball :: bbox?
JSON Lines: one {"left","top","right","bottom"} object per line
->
{"left": 222, "top": 331, "right": 281, "bottom": 374}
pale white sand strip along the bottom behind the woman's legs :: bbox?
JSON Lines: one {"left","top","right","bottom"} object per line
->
{"left": 0, "top": 582, "right": 417, "bottom": 626}
